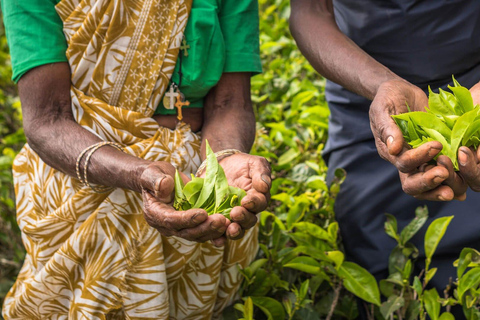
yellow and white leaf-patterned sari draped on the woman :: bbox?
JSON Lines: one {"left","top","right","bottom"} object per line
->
{"left": 3, "top": 0, "right": 257, "bottom": 320}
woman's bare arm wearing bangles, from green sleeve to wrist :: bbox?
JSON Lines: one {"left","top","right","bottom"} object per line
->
{"left": 19, "top": 64, "right": 149, "bottom": 191}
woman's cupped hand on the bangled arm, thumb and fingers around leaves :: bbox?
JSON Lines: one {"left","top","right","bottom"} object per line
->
{"left": 140, "top": 162, "right": 230, "bottom": 245}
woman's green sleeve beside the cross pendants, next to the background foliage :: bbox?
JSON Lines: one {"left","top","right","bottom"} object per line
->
{"left": 219, "top": 0, "right": 262, "bottom": 74}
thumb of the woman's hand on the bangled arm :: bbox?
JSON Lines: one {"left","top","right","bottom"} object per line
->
{"left": 140, "top": 165, "right": 175, "bottom": 203}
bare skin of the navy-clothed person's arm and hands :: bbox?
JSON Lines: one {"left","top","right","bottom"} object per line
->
{"left": 290, "top": 0, "right": 480, "bottom": 201}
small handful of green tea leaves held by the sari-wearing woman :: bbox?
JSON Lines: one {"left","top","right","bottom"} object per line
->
{"left": 173, "top": 142, "right": 246, "bottom": 219}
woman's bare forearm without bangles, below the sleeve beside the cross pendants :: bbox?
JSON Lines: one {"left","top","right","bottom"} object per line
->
{"left": 202, "top": 73, "right": 255, "bottom": 159}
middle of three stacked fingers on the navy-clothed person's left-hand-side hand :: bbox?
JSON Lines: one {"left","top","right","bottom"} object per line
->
{"left": 401, "top": 166, "right": 449, "bottom": 196}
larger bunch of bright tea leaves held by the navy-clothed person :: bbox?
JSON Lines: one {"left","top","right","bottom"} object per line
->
{"left": 392, "top": 78, "right": 480, "bottom": 171}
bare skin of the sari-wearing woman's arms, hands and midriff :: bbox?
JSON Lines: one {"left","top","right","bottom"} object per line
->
{"left": 18, "top": 63, "right": 271, "bottom": 246}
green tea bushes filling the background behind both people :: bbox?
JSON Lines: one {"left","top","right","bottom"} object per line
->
{"left": 0, "top": 0, "right": 480, "bottom": 320}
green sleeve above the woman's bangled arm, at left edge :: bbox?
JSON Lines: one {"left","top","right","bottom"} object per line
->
{"left": 1, "top": 0, "right": 67, "bottom": 82}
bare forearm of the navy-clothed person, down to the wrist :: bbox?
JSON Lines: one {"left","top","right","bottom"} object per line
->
{"left": 290, "top": 0, "right": 400, "bottom": 100}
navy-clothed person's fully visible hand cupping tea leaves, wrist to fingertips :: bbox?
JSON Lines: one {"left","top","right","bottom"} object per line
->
{"left": 370, "top": 80, "right": 466, "bottom": 201}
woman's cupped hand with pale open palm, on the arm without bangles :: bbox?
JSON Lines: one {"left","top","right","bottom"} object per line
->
{"left": 219, "top": 153, "right": 272, "bottom": 239}
